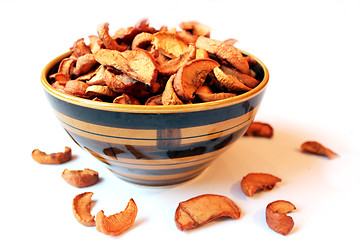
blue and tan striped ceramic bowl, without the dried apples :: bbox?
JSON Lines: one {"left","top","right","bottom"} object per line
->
{"left": 41, "top": 52, "right": 269, "bottom": 185}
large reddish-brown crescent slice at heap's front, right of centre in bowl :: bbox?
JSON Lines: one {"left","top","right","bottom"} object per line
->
{"left": 173, "top": 58, "right": 220, "bottom": 102}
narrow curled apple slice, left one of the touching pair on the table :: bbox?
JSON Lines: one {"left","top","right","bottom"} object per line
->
{"left": 72, "top": 192, "right": 95, "bottom": 227}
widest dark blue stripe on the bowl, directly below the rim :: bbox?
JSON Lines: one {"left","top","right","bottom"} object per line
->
{"left": 46, "top": 92, "right": 264, "bottom": 129}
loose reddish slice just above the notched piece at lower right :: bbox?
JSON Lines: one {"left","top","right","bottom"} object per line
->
{"left": 241, "top": 173, "right": 281, "bottom": 197}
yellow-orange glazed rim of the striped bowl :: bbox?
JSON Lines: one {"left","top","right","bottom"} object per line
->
{"left": 40, "top": 49, "right": 269, "bottom": 114}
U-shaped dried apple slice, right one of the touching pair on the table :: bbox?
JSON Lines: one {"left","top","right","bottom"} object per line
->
{"left": 96, "top": 199, "right": 138, "bottom": 236}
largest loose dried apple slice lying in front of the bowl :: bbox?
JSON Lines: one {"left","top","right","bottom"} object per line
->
{"left": 175, "top": 194, "right": 241, "bottom": 231}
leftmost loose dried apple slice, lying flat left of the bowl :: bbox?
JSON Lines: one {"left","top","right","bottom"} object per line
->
{"left": 31, "top": 147, "right": 71, "bottom": 164}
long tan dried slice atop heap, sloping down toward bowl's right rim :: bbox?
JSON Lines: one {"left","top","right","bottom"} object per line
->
{"left": 195, "top": 36, "right": 249, "bottom": 74}
